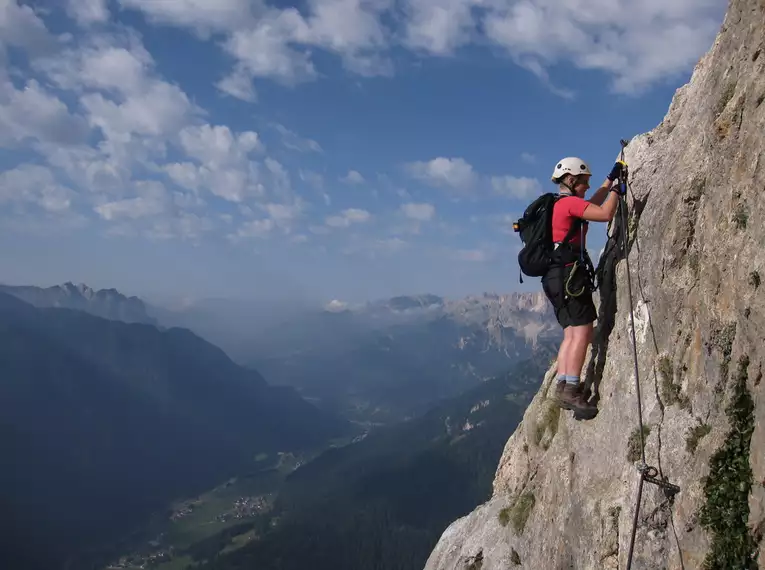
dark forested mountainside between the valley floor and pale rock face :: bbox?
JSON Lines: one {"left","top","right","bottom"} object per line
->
{"left": 128, "top": 361, "right": 545, "bottom": 570}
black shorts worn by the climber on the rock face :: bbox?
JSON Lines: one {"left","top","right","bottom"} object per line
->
{"left": 542, "top": 265, "right": 598, "bottom": 329}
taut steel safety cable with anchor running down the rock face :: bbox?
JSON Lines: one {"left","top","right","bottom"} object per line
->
{"left": 618, "top": 140, "right": 680, "bottom": 570}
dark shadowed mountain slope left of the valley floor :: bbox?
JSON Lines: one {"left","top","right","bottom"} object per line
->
{"left": 0, "top": 291, "right": 350, "bottom": 570}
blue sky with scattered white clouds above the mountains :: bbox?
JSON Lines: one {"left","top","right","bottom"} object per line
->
{"left": 0, "top": 0, "right": 725, "bottom": 303}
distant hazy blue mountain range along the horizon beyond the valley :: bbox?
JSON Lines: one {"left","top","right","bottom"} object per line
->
{"left": 0, "top": 283, "right": 561, "bottom": 424}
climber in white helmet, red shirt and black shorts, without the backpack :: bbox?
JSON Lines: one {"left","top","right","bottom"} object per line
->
{"left": 542, "top": 157, "right": 625, "bottom": 419}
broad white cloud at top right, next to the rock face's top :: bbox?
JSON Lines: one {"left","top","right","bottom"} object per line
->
{"left": 484, "top": 0, "right": 724, "bottom": 93}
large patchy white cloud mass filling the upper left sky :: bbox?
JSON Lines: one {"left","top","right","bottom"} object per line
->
{"left": 0, "top": 0, "right": 298, "bottom": 243}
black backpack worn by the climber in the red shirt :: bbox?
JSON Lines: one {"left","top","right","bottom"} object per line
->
{"left": 513, "top": 192, "right": 584, "bottom": 283}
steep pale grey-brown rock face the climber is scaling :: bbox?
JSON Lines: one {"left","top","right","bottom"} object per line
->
{"left": 426, "top": 0, "right": 765, "bottom": 570}
